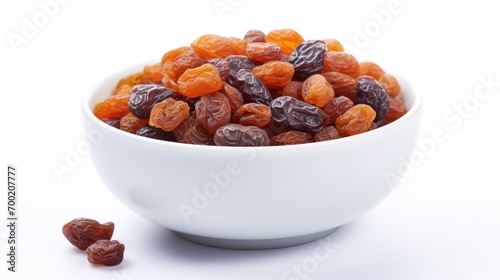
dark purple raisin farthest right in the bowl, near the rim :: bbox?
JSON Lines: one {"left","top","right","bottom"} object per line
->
{"left": 356, "top": 76, "right": 389, "bottom": 121}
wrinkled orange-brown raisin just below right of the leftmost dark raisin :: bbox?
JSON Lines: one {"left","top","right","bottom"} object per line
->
{"left": 149, "top": 97, "right": 190, "bottom": 131}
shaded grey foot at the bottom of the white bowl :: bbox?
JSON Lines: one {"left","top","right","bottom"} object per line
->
{"left": 174, "top": 227, "right": 338, "bottom": 250}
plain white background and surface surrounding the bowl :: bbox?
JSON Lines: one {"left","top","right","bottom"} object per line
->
{"left": 0, "top": 0, "right": 500, "bottom": 280}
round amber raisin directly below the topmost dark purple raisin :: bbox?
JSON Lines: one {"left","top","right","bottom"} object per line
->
{"left": 301, "top": 74, "right": 335, "bottom": 107}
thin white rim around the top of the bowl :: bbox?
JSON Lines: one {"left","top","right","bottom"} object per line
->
{"left": 81, "top": 61, "right": 423, "bottom": 152}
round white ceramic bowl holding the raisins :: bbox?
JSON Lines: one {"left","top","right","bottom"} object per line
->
{"left": 82, "top": 63, "right": 422, "bottom": 249}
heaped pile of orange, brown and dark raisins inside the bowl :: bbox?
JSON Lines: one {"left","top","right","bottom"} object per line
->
{"left": 94, "top": 29, "right": 406, "bottom": 146}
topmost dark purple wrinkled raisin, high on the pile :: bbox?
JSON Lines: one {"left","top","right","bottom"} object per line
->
{"left": 288, "top": 40, "right": 326, "bottom": 79}
